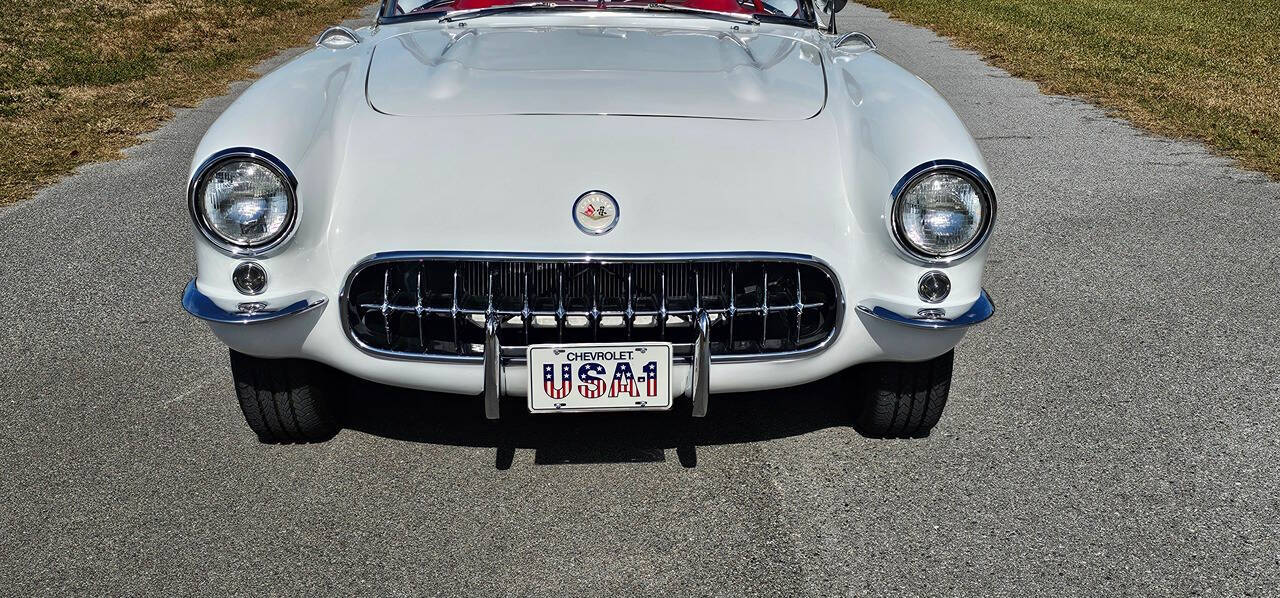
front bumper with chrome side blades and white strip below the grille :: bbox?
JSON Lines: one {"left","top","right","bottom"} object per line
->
{"left": 183, "top": 274, "right": 993, "bottom": 417}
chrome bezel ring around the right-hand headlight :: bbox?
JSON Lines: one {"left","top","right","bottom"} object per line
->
{"left": 890, "top": 160, "right": 996, "bottom": 265}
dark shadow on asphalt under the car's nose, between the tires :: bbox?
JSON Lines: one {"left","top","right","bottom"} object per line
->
{"left": 342, "top": 376, "right": 855, "bottom": 469}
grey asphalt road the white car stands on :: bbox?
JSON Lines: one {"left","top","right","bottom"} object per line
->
{"left": 0, "top": 5, "right": 1280, "bottom": 597}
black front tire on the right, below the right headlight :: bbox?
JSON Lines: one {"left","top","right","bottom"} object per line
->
{"left": 854, "top": 351, "right": 955, "bottom": 438}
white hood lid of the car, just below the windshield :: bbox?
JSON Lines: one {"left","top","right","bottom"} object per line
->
{"left": 367, "top": 27, "right": 827, "bottom": 120}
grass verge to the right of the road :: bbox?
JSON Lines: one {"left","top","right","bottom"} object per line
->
{"left": 858, "top": 0, "right": 1280, "bottom": 177}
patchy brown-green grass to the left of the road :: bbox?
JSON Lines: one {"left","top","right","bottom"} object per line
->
{"left": 0, "top": 0, "right": 370, "bottom": 205}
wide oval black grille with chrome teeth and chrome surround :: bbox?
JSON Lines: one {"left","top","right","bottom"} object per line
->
{"left": 340, "top": 254, "right": 842, "bottom": 361}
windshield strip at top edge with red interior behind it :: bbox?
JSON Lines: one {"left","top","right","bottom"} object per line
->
{"left": 383, "top": 0, "right": 812, "bottom": 22}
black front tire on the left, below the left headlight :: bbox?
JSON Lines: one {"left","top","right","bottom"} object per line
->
{"left": 232, "top": 351, "right": 340, "bottom": 444}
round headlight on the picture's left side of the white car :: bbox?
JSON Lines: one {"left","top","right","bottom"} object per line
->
{"left": 192, "top": 155, "right": 297, "bottom": 255}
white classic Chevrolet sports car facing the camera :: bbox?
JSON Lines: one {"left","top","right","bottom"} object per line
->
{"left": 183, "top": 0, "right": 996, "bottom": 443}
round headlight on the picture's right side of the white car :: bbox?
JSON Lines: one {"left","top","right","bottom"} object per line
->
{"left": 893, "top": 166, "right": 995, "bottom": 261}
